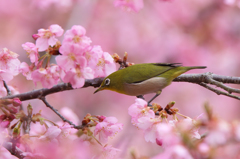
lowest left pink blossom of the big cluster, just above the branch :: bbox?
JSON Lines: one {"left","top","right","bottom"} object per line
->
{"left": 32, "top": 65, "right": 60, "bottom": 88}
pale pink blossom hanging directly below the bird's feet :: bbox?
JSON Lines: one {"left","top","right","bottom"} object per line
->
{"left": 128, "top": 98, "right": 155, "bottom": 125}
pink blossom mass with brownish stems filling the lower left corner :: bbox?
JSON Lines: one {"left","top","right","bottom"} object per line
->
{"left": 0, "top": 105, "right": 123, "bottom": 159}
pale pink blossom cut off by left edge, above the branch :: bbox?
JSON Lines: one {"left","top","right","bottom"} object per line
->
{"left": 0, "top": 48, "right": 20, "bottom": 76}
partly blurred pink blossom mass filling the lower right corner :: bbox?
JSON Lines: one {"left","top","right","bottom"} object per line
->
{"left": 128, "top": 99, "right": 240, "bottom": 159}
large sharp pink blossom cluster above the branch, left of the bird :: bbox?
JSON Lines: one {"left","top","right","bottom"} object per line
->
{"left": 19, "top": 24, "right": 116, "bottom": 88}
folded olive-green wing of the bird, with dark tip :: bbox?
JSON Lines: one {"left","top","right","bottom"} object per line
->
{"left": 123, "top": 63, "right": 181, "bottom": 84}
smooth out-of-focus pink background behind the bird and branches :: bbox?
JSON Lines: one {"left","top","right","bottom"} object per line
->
{"left": 0, "top": 0, "right": 240, "bottom": 158}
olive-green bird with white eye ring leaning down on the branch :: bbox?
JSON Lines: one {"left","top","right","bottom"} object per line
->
{"left": 94, "top": 63, "right": 206, "bottom": 103}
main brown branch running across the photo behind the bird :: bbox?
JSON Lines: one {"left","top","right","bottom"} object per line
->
{"left": 0, "top": 72, "right": 240, "bottom": 101}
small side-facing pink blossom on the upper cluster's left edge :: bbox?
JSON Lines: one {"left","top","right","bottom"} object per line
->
{"left": 22, "top": 42, "right": 39, "bottom": 65}
